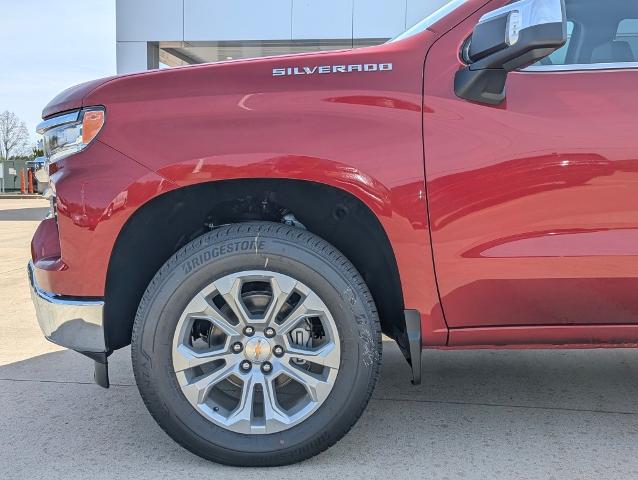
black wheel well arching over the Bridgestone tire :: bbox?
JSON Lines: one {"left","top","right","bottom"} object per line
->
{"left": 104, "top": 179, "right": 405, "bottom": 350}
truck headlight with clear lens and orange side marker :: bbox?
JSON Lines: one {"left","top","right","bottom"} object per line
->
{"left": 37, "top": 107, "right": 104, "bottom": 163}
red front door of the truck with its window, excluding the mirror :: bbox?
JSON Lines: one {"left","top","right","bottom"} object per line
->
{"left": 424, "top": 0, "right": 638, "bottom": 328}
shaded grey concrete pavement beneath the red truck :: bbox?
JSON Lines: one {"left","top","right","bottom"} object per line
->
{"left": 0, "top": 342, "right": 638, "bottom": 480}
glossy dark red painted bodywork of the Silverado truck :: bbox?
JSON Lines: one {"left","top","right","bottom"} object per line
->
{"left": 32, "top": 0, "right": 638, "bottom": 348}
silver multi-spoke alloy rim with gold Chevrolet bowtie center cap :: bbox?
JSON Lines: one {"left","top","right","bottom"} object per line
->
{"left": 172, "top": 270, "right": 341, "bottom": 434}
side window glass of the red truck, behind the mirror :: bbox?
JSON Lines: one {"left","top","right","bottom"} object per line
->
{"left": 531, "top": 0, "right": 638, "bottom": 70}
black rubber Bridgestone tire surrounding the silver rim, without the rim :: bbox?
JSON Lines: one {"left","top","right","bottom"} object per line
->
{"left": 133, "top": 224, "right": 381, "bottom": 464}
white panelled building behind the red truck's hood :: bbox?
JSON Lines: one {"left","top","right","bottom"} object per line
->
{"left": 117, "top": 0, "right": 449, "bottom": 73}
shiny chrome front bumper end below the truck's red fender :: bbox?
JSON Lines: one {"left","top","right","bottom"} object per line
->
{"left": 28, "top": 262, "right": 107, "bottom": 358}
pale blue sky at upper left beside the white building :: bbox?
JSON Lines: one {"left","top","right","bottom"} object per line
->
{"left": 0, "top": 0, "right": 115, "bottom": 143}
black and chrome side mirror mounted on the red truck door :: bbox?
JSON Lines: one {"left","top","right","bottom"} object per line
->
{"left": 454, "top": 0, "right": 567, "bottom": 105}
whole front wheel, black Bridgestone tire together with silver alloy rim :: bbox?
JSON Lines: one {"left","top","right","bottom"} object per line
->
{"left": 132, "top": 222, "right": 381, "bottom": 466}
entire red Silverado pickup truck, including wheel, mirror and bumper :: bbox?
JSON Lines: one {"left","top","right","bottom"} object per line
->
{"left": 29, "top": 0, "right": 638, "bottom": 465}
